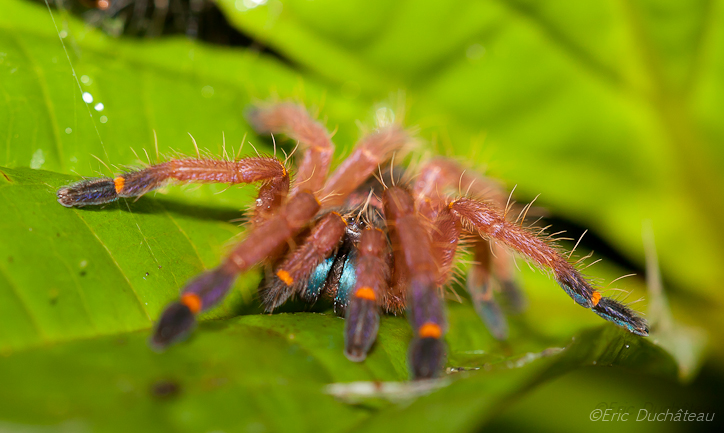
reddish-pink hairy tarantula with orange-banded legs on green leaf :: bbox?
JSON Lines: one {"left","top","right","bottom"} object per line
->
{"left": 57, "top": 103, "right": 648, "bottom": 378}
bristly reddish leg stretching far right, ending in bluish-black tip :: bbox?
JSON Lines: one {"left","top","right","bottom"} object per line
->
{"left": 449, "top": 197, "right": 649, "bottom": 336}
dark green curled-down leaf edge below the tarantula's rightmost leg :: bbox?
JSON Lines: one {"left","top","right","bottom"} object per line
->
{"left": 350, "top": 327, "right": 677, "bottom": 432}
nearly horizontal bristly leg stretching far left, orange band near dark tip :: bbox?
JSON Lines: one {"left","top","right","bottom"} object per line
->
{"left": 57, "top": 157, "right": 289, "bottom": 207}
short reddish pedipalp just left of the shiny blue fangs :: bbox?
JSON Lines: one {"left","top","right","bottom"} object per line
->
{"left": 259, "top": 212, "right": 347, "bottom": 312}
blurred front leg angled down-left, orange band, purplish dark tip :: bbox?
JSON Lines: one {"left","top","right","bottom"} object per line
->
{"left": 150, "top": 191, "right": 321, "bottom": 350}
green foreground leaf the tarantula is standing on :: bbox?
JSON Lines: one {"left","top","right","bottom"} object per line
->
{"left": 0, "top": 168, "right": 677, "bottom": 431}
